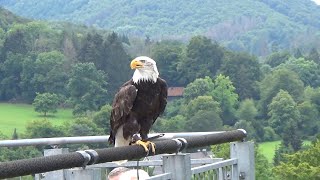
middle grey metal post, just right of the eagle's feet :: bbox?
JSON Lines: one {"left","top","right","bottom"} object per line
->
{"left": 162, "top": 154, "right": 192, "bottom": 180}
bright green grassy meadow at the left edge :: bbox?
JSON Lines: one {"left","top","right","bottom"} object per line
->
{"left": 0, "top": 103, "right": 73, "bottom": 137}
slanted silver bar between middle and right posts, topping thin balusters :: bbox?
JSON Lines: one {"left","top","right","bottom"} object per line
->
{"left": 191, "top": 159, "right": 238, "bottom": 174}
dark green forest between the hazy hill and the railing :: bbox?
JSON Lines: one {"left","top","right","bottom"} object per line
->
{"left": 0, "top": 1, "right": 320, "bottom": 179}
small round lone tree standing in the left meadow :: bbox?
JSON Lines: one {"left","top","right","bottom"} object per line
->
{"left": 32, "top": 93, "right": 61, "bottom": 117}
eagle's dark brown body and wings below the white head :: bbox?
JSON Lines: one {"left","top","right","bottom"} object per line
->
{"left": 109, "top": 77, "right": 167, "bottom": 145}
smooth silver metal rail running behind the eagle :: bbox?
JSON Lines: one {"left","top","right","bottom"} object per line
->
{"left": 0, "top": 131, "right": 223, "bottom": 147}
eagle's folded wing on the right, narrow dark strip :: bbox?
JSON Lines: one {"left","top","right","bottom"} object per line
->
{"left": 153, "top": 78, "right": 168, "bottom": 123}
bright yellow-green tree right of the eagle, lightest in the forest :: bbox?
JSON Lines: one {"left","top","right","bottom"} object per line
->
{"left": 212, "top": 74, "right": 238, "bottom": 126}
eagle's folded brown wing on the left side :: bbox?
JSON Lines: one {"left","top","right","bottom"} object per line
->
{"left": 108, "top": 80, "right": 137, "bottom": 144}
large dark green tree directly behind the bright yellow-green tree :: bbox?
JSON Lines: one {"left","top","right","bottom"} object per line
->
{"left": 219, "top": 53, "right": 261, "bottom": 100}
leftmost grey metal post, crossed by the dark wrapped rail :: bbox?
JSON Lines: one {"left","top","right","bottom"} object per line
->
{"left": 35, "top": 148, "right": 69, "bottom": 180}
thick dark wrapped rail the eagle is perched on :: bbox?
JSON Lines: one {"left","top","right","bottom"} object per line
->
{"left": 0, "top": 130, "right": 247, "bottom": 179}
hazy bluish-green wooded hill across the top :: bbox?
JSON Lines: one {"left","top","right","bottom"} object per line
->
{"left": 0, "top": 0, "right": 320, "bottom": 56}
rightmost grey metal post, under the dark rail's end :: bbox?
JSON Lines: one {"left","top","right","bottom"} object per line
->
{"left": 230, "top": 142, "right": 255, "bottom": 180}
